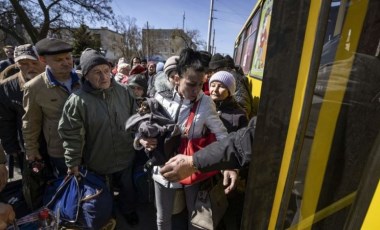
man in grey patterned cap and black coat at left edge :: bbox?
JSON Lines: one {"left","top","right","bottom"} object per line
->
{"left": 0, "top": 44, "right": 45, "bottom": 183}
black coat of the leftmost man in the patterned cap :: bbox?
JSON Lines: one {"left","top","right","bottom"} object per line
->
{"left": 0, "top": 72, "right": 25, "bottom": 154}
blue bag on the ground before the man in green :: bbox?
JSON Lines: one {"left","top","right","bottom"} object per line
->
{"left": 44, "top": 169, "right": 112, "bottom": 229}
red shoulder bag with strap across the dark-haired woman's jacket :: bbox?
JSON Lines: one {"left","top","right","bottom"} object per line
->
{"left": 178, "top": 101, "right": 219, "bottom": 185}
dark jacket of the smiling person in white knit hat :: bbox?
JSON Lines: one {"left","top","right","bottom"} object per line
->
{"left": 215, "top": 97, "right": 248, "bottom": 133}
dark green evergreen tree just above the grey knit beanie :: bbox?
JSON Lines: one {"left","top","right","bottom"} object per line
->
{"left": 73, "top": 24, "right": 101, "bottom": 56}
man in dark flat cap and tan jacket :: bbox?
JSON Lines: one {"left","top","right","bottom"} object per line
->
{"left": 22, "top": 38, "right": 80, "bottom": 176}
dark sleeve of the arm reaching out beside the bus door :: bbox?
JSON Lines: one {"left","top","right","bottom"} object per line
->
{"left": 193, "top": 118, "right": 256, "bottom": 172}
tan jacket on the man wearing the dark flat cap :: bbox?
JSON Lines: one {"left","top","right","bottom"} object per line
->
{"left": 22, "top": 68, "right": 80, "bottom": 157}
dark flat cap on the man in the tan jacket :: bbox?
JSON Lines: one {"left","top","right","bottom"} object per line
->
{"left": 36, "top": 38, "right": 73, "bottom": 56}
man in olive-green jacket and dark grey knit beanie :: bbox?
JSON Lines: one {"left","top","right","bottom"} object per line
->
{"left": 58, "top": 49, "right": 138, "bottom": 225}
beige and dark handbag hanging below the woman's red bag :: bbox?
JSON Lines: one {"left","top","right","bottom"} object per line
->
{"left": 191, "top": 179, "right": 228, "bottom": 230}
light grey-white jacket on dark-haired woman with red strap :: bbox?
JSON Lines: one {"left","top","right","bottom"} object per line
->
{"left": 153, "top": 91, "right": 227, "bottom": 188}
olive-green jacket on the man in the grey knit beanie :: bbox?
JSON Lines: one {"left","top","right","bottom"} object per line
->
{"left": 58, "top": 80, "right": 137, "bottom": 175}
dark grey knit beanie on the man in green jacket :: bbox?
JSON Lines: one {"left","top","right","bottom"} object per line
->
{"left": 80, "top": 48, "right": 110, "bottom": 76}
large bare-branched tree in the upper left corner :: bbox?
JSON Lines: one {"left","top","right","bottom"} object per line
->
{"left": 0, "top": 0, "right": 116, "bottom": 44}
